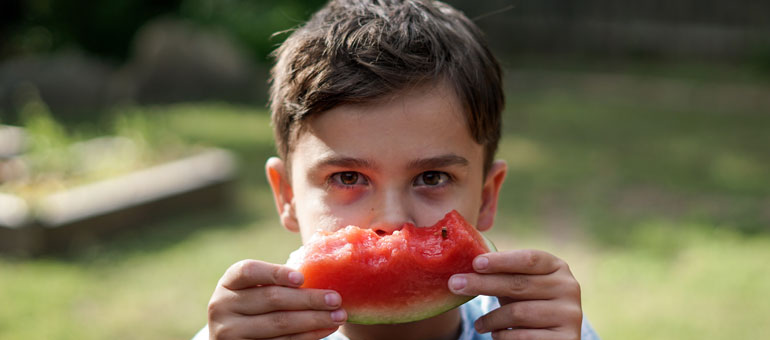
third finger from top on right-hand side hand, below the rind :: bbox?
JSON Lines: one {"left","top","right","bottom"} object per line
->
{"left": 474, "top": 300, "right": 582, "bottom": 333}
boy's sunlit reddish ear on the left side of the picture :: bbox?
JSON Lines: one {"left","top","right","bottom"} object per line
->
{"left": 265, "top": 157, "right": 299, "bottom": 232}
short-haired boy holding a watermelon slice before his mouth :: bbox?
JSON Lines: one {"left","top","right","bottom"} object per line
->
{"left": 198, "top": 0, "right": 596, "bottom": 340}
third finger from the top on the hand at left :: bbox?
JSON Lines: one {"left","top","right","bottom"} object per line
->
{"left": 234, "top": 309, "right": 347, "bottom": 339}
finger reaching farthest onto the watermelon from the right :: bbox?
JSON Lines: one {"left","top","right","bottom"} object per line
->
{"left": 449, "top": 273, "right": 569, "bottom": 300}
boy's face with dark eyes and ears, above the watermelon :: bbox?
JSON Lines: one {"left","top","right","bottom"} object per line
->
{"left": 267, "top": 82, "right": 505, "bottom": 242}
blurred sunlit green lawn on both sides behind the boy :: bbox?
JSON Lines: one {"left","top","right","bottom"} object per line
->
{"left": 0, "top": 65, "right": 770, "bottom": 340}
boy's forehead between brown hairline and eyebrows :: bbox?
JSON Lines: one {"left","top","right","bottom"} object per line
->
{"left": 288, "top": 79, "right": 480, "bottom": 158}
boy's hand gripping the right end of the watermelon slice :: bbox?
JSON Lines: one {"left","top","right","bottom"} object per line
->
{"left": 449, "top": 250, "right": 583, "bottom": 340}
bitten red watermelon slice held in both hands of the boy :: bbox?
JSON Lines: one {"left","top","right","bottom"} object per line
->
{"left": 289, "top": 211, "right": 494, "bottom": 324}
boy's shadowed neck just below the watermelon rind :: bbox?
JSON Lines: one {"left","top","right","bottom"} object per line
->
{"left": 341, "top": 308, "right": 461, "bottom": 340}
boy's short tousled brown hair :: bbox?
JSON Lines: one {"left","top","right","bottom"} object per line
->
{"left": 270, "top": 0, "right": 504, "bottom": 173}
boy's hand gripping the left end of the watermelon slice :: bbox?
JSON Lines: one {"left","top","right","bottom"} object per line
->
{"left": 208, "top": 260, "right": 347, "bottom": 340}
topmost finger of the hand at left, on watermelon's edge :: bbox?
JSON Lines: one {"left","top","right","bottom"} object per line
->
{"left": 219, "top": 260, "right": 304, "bottom": 290}
